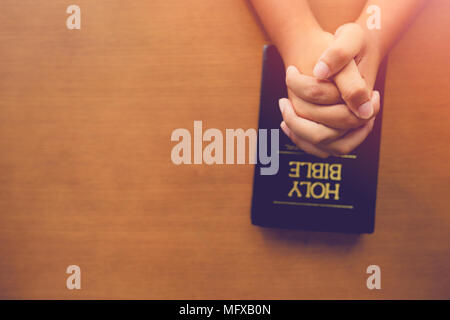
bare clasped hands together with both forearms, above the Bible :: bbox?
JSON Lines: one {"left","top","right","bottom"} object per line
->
{"left": 251, "top": 0, "right": 427, "bottom": 157}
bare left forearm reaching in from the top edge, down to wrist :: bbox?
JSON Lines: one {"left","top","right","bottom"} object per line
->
{"left": 250, "top": 0, "right": 321, "bottom": 61}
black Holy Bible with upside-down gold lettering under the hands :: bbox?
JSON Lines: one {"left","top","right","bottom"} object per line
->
{"left": 251, "top": 45, "right": 387, "bottom": 233}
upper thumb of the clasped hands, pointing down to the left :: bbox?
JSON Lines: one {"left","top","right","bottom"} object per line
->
{"left": 313, "top": 23, "right": 364, "bottom": 79}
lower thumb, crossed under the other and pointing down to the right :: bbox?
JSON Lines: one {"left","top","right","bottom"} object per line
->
{"left": 334, "top": 60, "right": 374, "bottom": 119}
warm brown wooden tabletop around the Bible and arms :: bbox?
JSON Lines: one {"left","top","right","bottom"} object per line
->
{"left": 0, "top": 0, "right": 450, "bottom": 299}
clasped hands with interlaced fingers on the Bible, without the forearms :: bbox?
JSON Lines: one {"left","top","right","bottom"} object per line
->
{"left": 279, "top": 23, "right": 380, "bottom": 158}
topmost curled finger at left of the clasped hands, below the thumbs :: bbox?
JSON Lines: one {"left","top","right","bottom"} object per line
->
{"left": 286, "top": 66, "right": 341, "bottom": 105}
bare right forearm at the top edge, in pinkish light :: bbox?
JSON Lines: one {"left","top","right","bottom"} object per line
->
{"left": 357, "top": 0, "right": 428, "bottom": 59}
